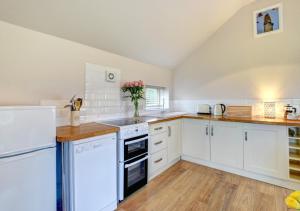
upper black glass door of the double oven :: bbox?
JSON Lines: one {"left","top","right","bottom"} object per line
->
{"left": 124, "top": 134, "right": 148, "bottom": 160}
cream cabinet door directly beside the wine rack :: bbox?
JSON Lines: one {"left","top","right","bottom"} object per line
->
{"left": 244, "top": 124, "right": 288, "bottom": 178}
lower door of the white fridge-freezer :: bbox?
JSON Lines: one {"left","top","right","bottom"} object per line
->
{"left": 0, "top": 148, "right": 56, "bottom": 211}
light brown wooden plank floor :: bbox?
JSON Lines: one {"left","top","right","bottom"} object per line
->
{"left": 118, "top": 161, "right": 291, "bottom": 211}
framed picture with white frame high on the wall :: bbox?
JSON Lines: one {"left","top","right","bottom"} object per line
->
{"left": 253, "top": 4, "right": 283, "bottom": 37}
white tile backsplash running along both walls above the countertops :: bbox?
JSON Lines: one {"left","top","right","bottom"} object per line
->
{"left": 41, "top": 63, "right": 300, "bottom": 126}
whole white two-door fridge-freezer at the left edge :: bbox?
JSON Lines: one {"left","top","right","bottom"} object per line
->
{"left": 0, "top": 106, "right": 56, "bottom": 211}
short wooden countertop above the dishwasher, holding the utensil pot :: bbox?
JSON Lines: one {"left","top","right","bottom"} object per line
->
{"left": 56, "top": 122, "right": 119, "bottom": 142}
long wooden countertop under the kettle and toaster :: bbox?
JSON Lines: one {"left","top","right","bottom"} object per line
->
{"left": 146, "top": 114, "right": 300, "bottom": 127}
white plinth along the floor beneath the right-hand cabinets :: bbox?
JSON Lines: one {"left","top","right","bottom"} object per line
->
{"left": 181, "top": 155, "right": 300, "bottom": 190}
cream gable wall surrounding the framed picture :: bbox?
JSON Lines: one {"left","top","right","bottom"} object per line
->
{"left": 174, "top": 0, "right": 300, "bottom": 101}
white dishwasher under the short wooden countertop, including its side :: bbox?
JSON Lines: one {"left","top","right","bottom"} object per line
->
{"left": 63, "top": 134, "right": 117, "bottom": 211}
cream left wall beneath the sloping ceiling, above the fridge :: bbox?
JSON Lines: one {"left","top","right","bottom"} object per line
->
{"left": 0, "top": 21, "right": 172, "bottom": 105}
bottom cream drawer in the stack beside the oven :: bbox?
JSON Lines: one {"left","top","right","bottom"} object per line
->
{"left": 149, "top": 149, "right": 167, "bottom": 174}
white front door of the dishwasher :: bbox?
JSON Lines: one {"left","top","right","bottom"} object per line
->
{"left": 72, "top": 135, "right": 117, "bottom": 211}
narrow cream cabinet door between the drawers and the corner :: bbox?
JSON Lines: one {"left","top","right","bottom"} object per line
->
{"left": 167, "top": 120, "right": 181, "bottom": 162}
